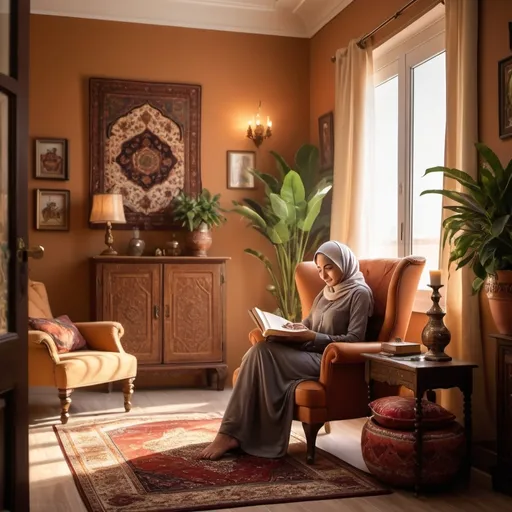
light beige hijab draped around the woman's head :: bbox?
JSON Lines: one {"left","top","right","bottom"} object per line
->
{"left": 313, "top": 240, "right": 373, "bottom": 316}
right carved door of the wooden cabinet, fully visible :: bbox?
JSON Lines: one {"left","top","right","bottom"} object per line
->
{"left": 164, "top": 263, "right": 224, "bottom": 363}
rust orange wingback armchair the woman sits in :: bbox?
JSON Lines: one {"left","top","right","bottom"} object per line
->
{"left": 233, "top": 256, "right": 425, "bottom": 464}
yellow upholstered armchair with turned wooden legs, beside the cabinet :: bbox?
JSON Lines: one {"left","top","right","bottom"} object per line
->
{"left": 28, "top": 280, "right": 137, "bottom": 423}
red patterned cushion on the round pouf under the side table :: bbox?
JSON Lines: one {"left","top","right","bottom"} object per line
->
{"left": 370, "top": 396, "right": 455, "bottom": 430}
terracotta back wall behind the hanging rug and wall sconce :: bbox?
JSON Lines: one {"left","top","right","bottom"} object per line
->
{"left": 29, "top": 15, "right": 309, "bottom": 384}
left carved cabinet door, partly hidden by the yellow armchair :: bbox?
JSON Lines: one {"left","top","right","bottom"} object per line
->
{"left": 102, "top": 263, "right": 162, "bottom": 364}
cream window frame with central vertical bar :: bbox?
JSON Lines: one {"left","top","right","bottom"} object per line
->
{"left": 373, "top": 9, "right": 446, "bottom": 312}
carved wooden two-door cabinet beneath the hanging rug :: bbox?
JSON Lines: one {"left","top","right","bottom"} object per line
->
{"left": 91, "top": 256, "right": 228, "bottom": 390}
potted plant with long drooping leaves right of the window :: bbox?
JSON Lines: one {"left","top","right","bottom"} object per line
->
{"left": 421, "top": 143, "right": 512, "bottom": 334}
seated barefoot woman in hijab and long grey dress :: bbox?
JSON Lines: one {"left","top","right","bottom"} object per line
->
{"left": 201, "top": 241, "right": 373, "bottom": 460}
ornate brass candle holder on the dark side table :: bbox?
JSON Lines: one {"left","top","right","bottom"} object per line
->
{"left": 421, "top": 284, "right": 452, "bottom": 362}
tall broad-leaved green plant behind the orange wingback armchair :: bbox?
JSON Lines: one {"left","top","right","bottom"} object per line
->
{"left": 233, "top": 145, "right": 332, "bottom": 322}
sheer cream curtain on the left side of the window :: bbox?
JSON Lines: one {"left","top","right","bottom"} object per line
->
{"left": 331, "top": 39, "right": 374, "bottom": 257}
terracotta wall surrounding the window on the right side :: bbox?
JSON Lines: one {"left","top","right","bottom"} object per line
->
{"left": 310, "top": 0, "right": 512, "bottom": 432}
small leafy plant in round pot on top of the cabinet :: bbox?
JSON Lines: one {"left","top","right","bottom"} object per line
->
{"left": 172, "top": 188, "right": 226, "bottom": 257}
